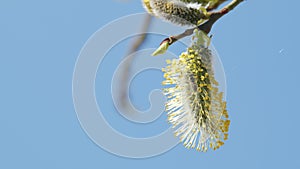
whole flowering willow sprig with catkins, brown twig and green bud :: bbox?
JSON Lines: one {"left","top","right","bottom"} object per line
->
{"left": 142, "top": 0, "right": 244, "bottom": 152}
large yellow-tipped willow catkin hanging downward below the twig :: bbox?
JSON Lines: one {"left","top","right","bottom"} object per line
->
{"left": 163, "top": 31, "right": 230, "bottom": 152}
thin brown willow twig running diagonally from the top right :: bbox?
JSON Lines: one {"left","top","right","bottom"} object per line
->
{"left": 161, "top": 0, "right": 244, "bottom": 45}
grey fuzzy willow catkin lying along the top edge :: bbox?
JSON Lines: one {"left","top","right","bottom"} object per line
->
{"left": 143, "top": 0, "right": 206, "bottom": 26}
